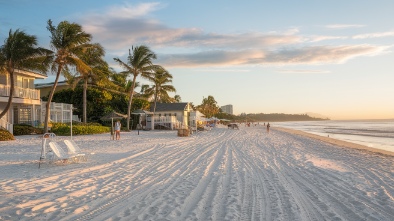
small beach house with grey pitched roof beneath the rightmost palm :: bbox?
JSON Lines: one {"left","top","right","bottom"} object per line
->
{"left": 150, "top": 102, "right": 193, "bottom": 130}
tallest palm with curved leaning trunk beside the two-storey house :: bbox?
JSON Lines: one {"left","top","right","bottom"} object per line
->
{"left": 44, "top": 20, "right": 93, "bottom": 132}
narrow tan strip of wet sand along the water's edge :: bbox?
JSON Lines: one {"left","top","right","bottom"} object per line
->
{"left": 272, "top": 127, "right": 394, "bottom": 157}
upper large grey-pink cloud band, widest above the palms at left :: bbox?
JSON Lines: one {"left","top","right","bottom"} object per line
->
{"left": 81, "top": 3, "right": 303, "bottom": 51}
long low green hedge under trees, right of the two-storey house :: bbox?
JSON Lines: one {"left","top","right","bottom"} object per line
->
{"left": 51, "top": 123, "right": 111, "bottom": 136}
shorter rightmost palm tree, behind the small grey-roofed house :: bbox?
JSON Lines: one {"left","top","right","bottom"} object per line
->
{"left": 145, "top": 67, "right": 176, "bottom": 113}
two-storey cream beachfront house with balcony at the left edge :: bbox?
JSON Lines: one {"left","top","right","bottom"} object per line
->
{"left": 0, "top": 70, "right": 47, "bottom": 133}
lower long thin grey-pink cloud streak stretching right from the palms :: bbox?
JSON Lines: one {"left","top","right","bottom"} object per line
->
{"left": 158, "top": 45, "right": 387, "bottom": 67}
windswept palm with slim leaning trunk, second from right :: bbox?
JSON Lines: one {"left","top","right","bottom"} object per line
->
{"left": 114, "top": 45, "right": 156, "bottom": 130}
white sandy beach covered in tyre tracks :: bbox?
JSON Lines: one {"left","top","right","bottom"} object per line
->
{"left": 0, "top": 127, "right": 394, "bottom": 221}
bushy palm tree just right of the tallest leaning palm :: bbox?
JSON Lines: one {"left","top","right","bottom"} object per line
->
{"left": 65, "top": 44, "right": 109, "bottom": 123}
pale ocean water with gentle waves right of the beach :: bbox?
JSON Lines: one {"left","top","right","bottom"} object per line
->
{"left": 270, "top": 119, "right": 394, "bottom": 152}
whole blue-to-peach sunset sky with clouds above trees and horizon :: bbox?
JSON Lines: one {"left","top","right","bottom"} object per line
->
{"left": 0, "top": 0, "right": 394, "bottom": 120}
